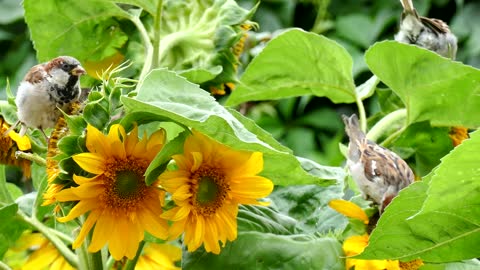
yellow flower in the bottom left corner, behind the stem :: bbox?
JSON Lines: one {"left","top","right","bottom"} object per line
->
{"left": 5, "top": 232, "right": 74, "bottom": 270}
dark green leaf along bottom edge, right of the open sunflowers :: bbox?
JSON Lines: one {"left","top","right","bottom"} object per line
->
{"left": 182, "top": 232, "right": 345, "bottom": 270}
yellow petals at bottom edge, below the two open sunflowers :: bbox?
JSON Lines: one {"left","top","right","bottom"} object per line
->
{"left": 135, "top": 243, "right": 182, "bottom": 270}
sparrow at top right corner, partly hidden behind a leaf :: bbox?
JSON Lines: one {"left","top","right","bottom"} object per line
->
{"left": 395, "top": 0, "right": 457, "bottom": 59}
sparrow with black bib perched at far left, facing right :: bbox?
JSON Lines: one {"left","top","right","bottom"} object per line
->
{"left": 15, "top": 56, "right": 86, "bottom": 138}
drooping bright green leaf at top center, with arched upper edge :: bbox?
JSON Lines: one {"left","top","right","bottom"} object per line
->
{"left": 227, "top": 29, "right": 355, "bottom": 106}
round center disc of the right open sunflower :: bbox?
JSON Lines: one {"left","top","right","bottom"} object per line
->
{"left": 191, "top": 167, "right": 230, "bottom": 216}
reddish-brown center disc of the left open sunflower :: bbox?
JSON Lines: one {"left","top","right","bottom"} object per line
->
{"left": 103, "top": 158, "right": 150, "bottom": 212}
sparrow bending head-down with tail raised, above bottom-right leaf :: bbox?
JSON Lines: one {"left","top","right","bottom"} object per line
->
{"left": 342, "top": 114, "right": 414, "bottom": 213}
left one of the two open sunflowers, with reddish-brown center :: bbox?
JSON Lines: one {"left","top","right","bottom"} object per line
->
{"left": 55, "top": 125, "right": 168, "bottom": 260}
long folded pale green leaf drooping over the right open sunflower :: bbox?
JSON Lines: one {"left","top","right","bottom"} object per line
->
{"left": 122, "top": 70, "right": 333, "bottom": 185}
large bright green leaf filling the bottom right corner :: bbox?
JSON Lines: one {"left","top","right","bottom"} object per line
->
{"left": 360, "top": 131, "right": 480, "bottom": 263}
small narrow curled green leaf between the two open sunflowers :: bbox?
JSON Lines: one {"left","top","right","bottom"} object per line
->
{"left": 145, "top": 131, "right": 191, "bottom": 185}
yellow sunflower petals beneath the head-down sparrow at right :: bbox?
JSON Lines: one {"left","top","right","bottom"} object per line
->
{"left": 328, "top": 200, "right": 423, "bottom": 270}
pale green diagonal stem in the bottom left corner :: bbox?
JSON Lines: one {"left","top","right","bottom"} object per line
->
{"left": 17, "top": 211, "right": 78, "bottom": 268}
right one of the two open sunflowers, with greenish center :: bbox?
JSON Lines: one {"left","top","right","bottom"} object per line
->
{"left": 160, "top": 131, "right": 273, "bottom": 254}
